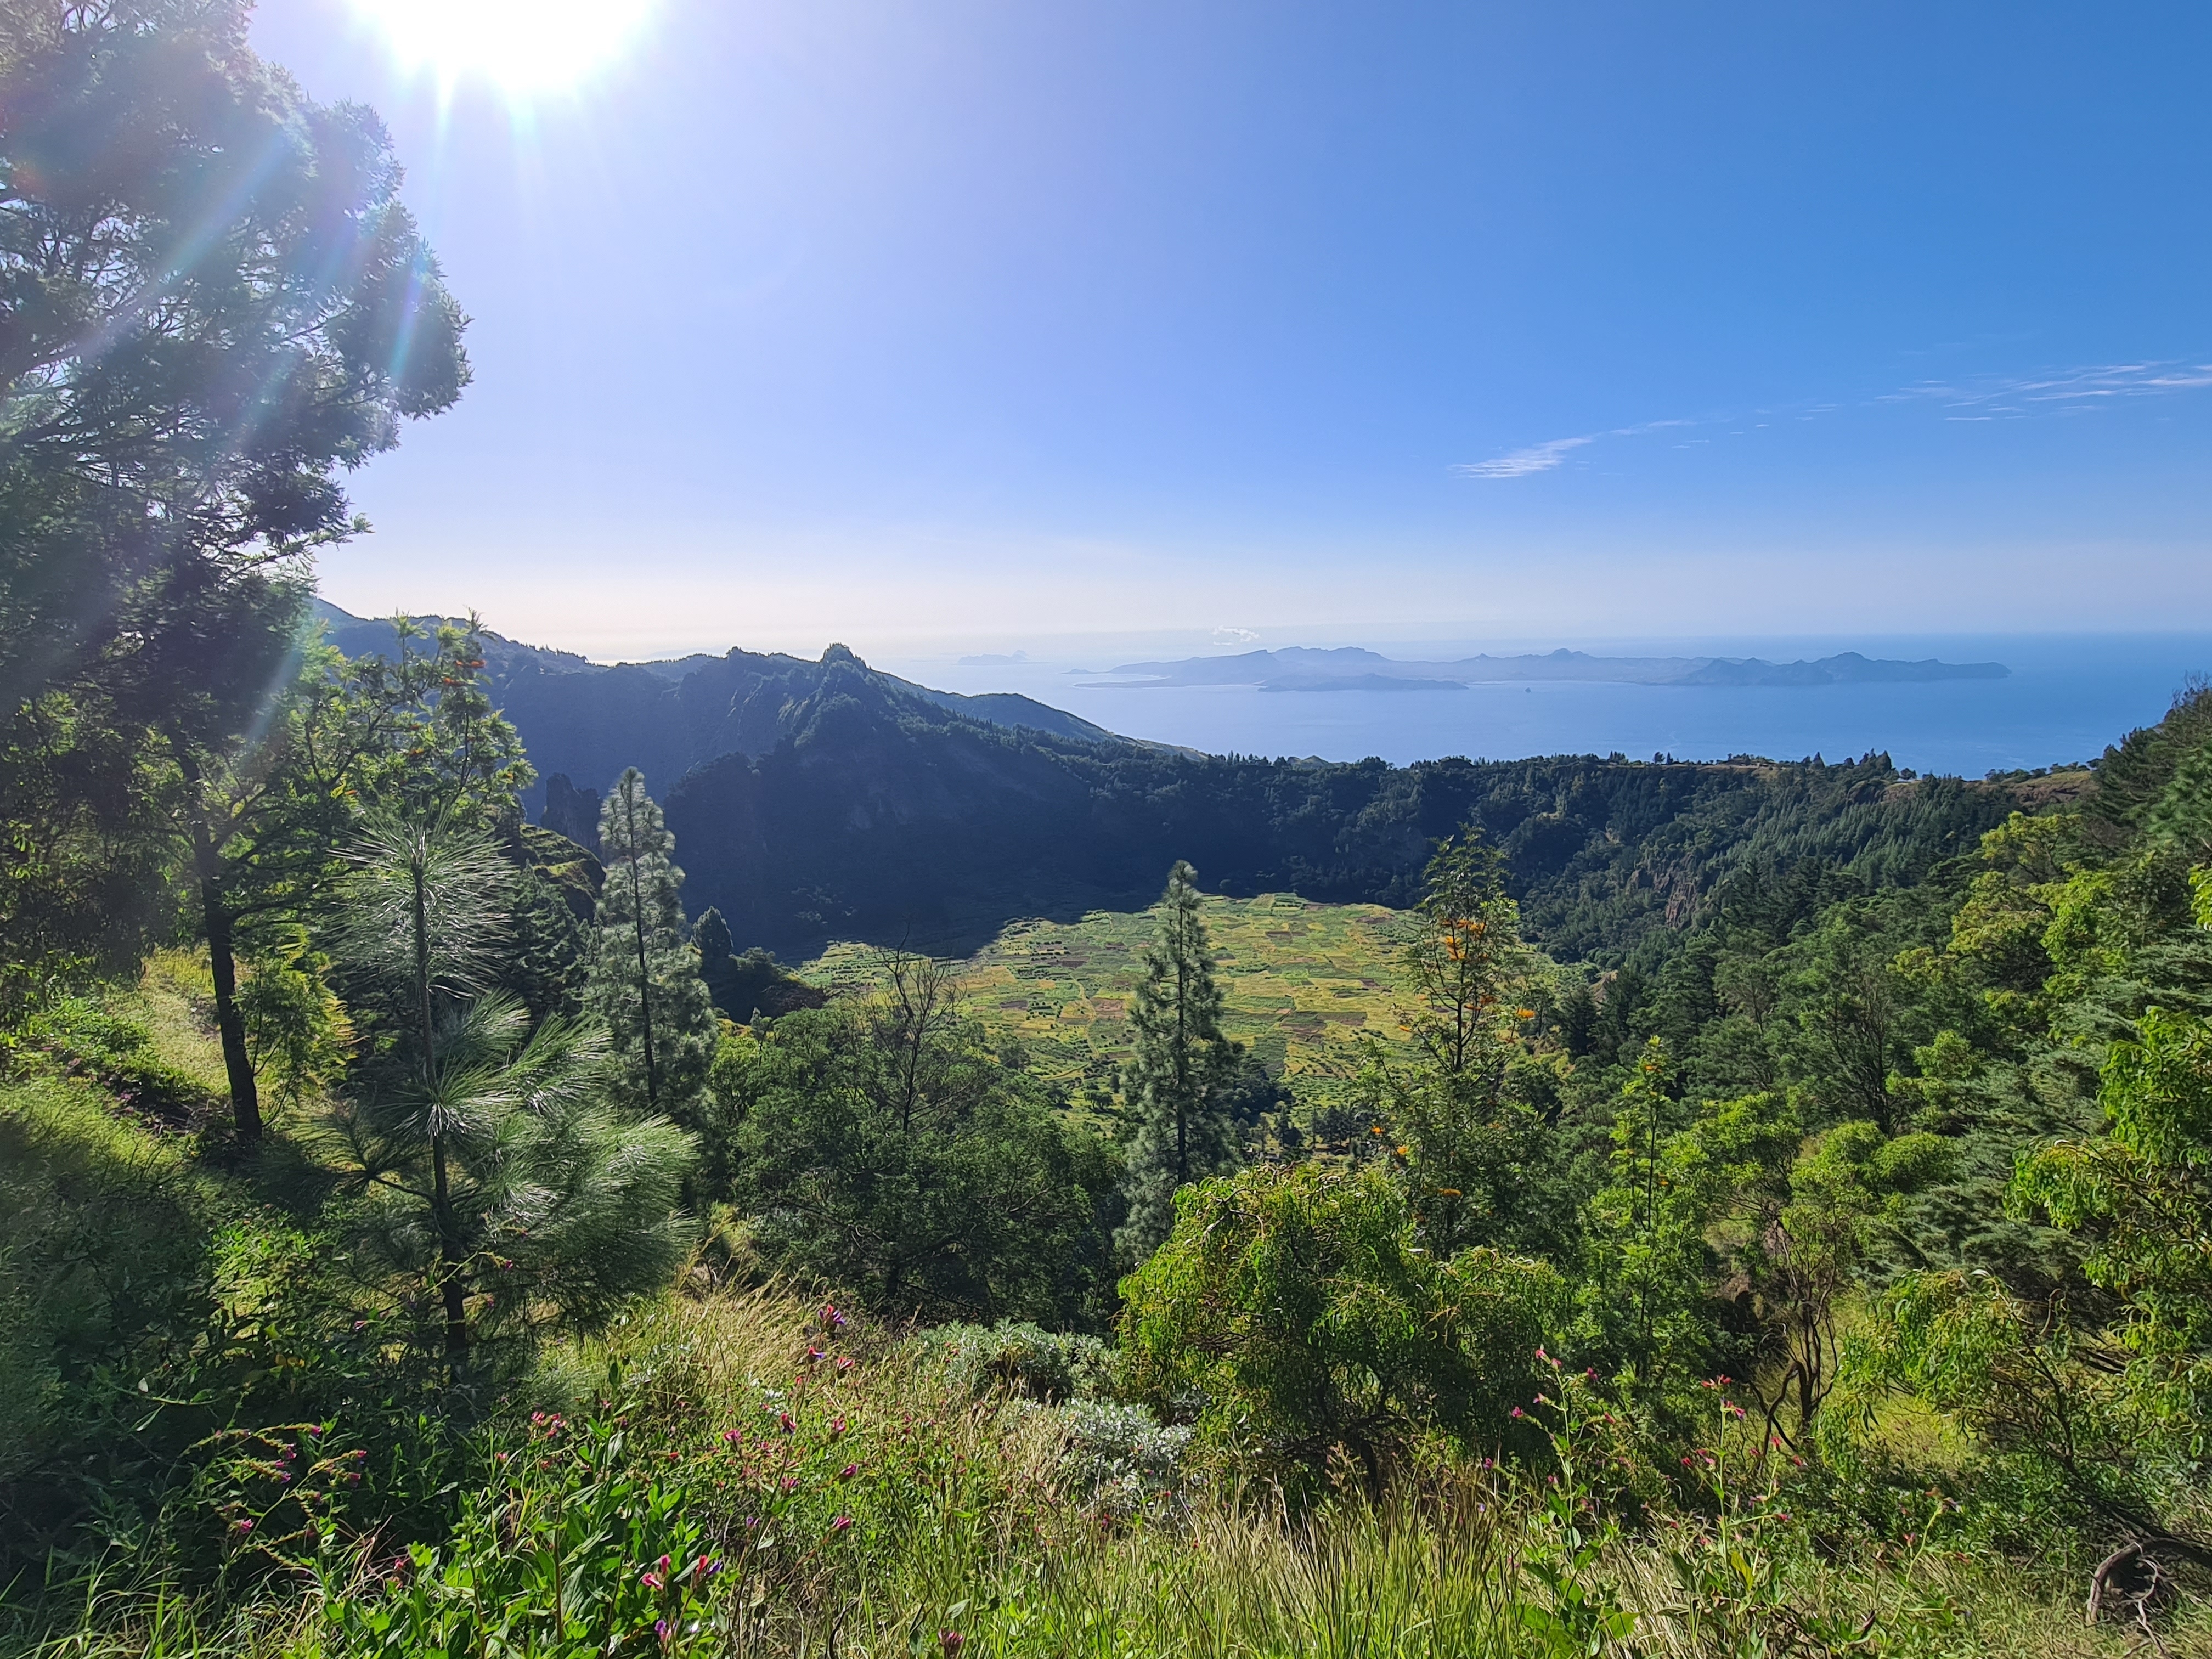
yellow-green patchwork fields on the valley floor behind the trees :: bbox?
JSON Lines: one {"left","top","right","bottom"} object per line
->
{"left": 799, "top": 894, "right": 1404, "bottom": 1097}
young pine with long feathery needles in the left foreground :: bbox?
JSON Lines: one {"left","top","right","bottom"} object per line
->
{"left": 332, "top": 814, "right": 690, "bottom": 1374}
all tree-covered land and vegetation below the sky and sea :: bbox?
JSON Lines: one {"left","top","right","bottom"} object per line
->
{"left": 0, "top": 0, "right": 2212, "bottom": 1659}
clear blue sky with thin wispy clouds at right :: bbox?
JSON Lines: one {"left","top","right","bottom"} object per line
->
{"left": 257, "top": 0, "right": 2212, "bottom": 657}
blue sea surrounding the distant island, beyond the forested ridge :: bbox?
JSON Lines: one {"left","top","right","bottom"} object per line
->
{"left": 876, "top": 630, "right": 2212, "bottom": 776}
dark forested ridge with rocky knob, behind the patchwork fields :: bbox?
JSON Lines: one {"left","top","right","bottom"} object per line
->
{"left": 312, "top": 613, "right": 2035, "bottom": 964}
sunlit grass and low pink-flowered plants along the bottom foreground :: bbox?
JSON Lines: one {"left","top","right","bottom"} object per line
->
{"left": 0, "top": 1256, "right": 2212, "bottom": 1659}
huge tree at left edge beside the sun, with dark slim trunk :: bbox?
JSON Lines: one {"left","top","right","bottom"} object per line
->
{"left": 0, "top": 0, "right": 467, "bottom": 1026}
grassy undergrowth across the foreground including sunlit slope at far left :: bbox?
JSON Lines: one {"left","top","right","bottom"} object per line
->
{"left": 0, "top": 1040, "right": 2212, "bottom": 1655}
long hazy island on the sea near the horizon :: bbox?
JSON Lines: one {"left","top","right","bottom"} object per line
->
{"left": 1077, "top": 646, "right": 2013, "bottom": 692}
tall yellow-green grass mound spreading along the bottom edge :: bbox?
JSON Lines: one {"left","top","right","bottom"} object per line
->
{"left": 13, "top": 1288, "right": 2212, "bottom": 1659}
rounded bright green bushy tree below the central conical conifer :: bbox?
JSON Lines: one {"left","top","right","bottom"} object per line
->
{"left": 1121, "top": 1164, "right": 1566, "bottom": 1491}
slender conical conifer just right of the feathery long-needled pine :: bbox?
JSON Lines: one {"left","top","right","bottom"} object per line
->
{"left": 586, "top": 765, "right": 714, "bottom": 1119}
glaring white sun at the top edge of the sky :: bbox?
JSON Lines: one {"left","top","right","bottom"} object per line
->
{"left": 354, "top": 0, "right": 652, "bottom": 95}
